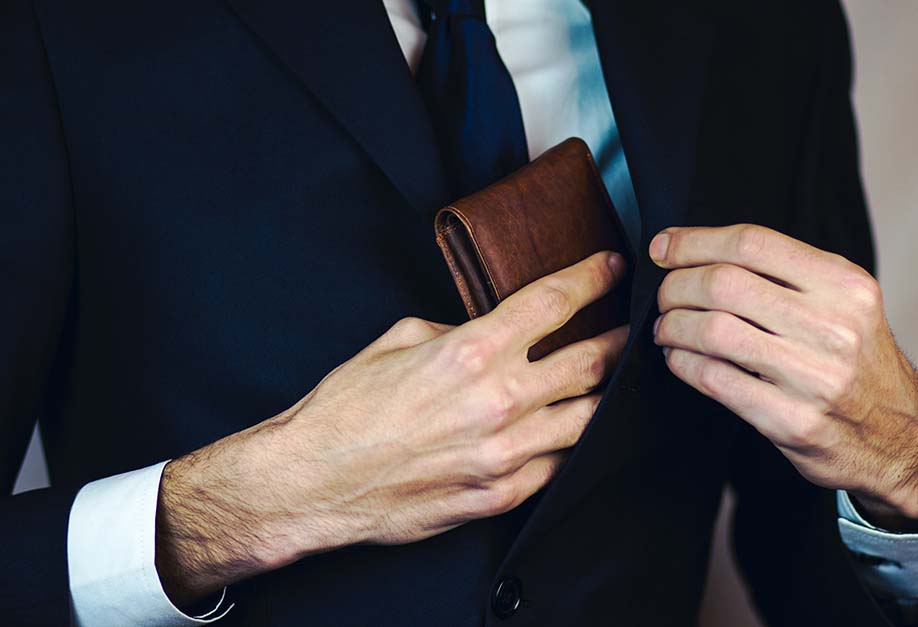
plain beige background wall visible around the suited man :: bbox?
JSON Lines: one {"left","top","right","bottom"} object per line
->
{"left": 10, "top": 0, "right": 918, "bottom": 627}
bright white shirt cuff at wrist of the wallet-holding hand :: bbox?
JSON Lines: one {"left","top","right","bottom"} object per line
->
{"left": 67, "top": 462, "right": 233, "bottom": 627}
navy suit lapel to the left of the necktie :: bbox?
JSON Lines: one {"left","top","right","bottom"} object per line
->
{"left": 227, "top": 0, "right": 449, "bottom": 219}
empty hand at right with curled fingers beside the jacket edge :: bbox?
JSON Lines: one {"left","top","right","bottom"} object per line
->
{"left": 650, "top": 225, "right": 918, "bottom": 529}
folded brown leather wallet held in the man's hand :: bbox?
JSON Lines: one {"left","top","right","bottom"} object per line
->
{"left": 434, "top": 137, "right": 634, "bottom": 361}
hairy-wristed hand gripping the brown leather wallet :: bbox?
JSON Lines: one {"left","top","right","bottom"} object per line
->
{"left": 157, "top": 253, "right": 628, "bottom": 603}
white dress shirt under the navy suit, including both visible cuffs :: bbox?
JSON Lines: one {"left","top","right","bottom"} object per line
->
{"left": 67, "top": 0, "right": 918, "bottom": 627}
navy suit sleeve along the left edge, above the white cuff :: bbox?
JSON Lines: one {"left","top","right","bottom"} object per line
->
{"left": 0, "top": 0, "right": 83, "bottom": 626}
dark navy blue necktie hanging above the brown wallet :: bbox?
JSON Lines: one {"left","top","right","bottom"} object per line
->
{"left": 417, "top": 0, "right": 529, "bottom": 196}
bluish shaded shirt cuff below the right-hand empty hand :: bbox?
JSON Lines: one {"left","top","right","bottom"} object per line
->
{"left": 837, "top": 490, "right": 918, "bottom": 621}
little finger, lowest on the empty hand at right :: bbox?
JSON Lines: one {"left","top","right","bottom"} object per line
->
{"left": 666, "top": 348, "right": 807, "bottom": 447}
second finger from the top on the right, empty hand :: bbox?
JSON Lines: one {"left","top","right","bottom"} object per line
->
{"left": 657, "top": 263, "right": 804, "bottom": 335}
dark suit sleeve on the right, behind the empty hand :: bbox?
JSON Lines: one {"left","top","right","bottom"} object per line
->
{"left": 731, "top": 0, "right": 904, "bottom": 627}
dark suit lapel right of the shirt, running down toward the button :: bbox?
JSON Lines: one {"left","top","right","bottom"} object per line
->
{"left": 511, "top": 0, "right": 713, "bottom": 556}
